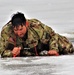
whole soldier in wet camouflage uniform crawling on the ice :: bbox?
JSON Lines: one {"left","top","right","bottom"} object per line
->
{"left": 0, "top": 12, "right": 74, "bottom": 57}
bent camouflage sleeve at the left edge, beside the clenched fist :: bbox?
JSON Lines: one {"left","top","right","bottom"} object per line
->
{"left": 0, "top": 24, "right": 14, "bottom": 57}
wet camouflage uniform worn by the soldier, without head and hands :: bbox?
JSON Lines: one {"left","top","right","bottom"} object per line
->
{"left": 0, "top": 19, "right": 73, "bottom": 57}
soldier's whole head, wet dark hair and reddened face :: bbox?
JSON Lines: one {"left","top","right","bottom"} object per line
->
{"left": 11, "top": 12, "right": 27, "bottom": 37}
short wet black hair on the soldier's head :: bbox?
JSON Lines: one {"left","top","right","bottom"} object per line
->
{"left": 11, "top": 12, "right": 26, "bottom": 27}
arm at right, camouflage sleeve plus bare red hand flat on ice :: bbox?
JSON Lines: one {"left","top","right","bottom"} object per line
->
{"left": 46, "top": 26, "right": 59, "bottom": 55}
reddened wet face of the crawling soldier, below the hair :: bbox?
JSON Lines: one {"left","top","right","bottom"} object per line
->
{"left": 13, "top": 25, "right": 27, "bottom": 38}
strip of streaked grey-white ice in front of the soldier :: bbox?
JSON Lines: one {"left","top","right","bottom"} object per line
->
{"left": 0, "top": 55, "right": 74, "bottom": 75}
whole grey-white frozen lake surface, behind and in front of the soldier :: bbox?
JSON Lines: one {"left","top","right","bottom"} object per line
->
{"left": 0, "top": 0, "right": 74, "bottom": 75}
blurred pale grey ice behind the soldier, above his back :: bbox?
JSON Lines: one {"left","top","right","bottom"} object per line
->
{"left": 0, "top": 0, "right": 74, "bottom": 38}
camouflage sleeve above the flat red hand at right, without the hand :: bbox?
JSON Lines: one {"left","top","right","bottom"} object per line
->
{"left": 45, "top": 26, "right": 59, "bottom": 52}
